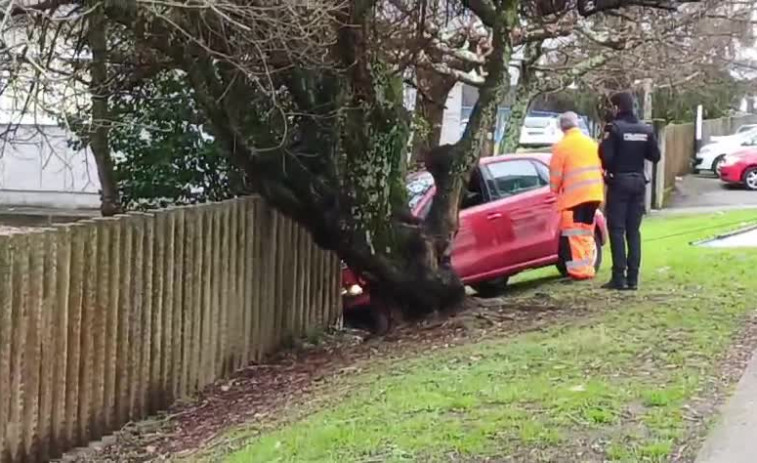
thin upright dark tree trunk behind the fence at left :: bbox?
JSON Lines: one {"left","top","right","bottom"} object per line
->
{"left": 87, "top": 2, "right": 122, "bottom": 217}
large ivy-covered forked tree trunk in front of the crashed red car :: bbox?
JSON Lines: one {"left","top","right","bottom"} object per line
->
{"left": 97, "top": 0, "right": 518, "bottom": 326}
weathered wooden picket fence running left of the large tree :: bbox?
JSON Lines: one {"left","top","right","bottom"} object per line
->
{"left": 0, "top": 198, "right": 341, "bottom": 463}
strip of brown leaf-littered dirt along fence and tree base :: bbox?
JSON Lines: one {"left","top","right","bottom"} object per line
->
{"left": 57, "top": 288, "right": 590, "bottom": 463}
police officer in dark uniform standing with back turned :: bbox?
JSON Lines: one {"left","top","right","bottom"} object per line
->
{"left": 599, "top": 92, "right": 660, "bottom": 290}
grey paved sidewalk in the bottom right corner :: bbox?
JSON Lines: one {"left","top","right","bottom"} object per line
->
{"left": 696, "top": 352, "right": 757, "bottom": 463}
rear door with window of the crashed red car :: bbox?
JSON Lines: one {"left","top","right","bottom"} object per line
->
{"left": 486, "top": 158, "right": 557, "bottom": 268}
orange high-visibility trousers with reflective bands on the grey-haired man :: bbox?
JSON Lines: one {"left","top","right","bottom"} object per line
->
{"left": 560, "top": 209, "right": 597, "bottom": 280}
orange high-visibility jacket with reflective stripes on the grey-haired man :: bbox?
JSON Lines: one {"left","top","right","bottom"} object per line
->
{"left": 549, "top": 129, "right": 605, "bottom": 210}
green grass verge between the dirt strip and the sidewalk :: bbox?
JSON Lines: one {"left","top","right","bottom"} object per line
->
{"left": 221, "top": 212, "right": 757, "bottom": 463}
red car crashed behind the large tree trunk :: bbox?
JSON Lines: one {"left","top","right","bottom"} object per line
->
{"left": 342, "top": 153, "right": 607, "bottom": 309}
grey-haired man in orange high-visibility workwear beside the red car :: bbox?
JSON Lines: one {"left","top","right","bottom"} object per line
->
{"left": 549, "top": 112, "right": 604, "bottom": 280}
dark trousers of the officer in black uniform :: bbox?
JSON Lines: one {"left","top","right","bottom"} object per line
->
{"left": 606, "top": 174, "right": 646, "bottom": 284}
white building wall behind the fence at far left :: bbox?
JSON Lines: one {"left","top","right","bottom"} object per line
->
{"left": 0, "top": 125, "right": 100, "bottom": 208}
